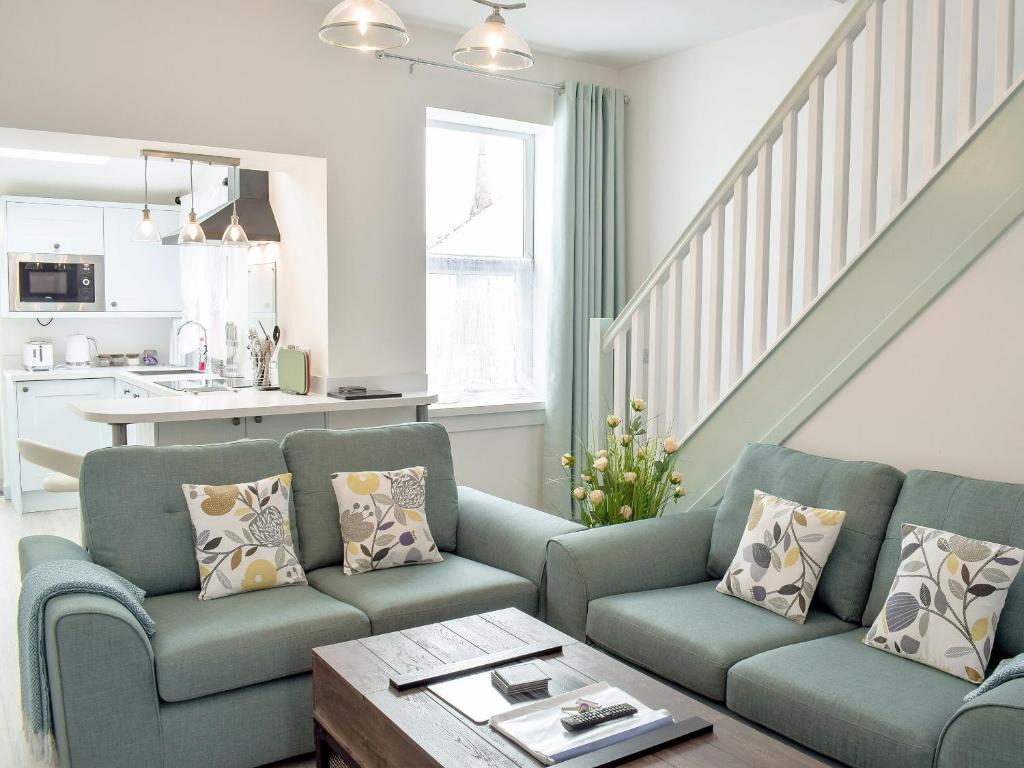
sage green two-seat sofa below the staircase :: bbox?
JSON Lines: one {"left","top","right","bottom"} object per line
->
{"left": 548, "top": 444, "right": 1024, "bottom": 768}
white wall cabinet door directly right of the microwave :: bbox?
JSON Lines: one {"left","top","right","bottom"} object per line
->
{"left": 103, "top": 207, "right": 182, "bottom": 315}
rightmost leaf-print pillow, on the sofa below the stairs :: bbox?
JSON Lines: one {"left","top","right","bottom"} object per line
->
{"left": 864, "top": 524, "right": 1024, "bottom": 683}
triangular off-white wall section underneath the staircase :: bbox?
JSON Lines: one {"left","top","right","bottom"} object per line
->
{"left": 786, "top": 214, "right": 1024, "bottom": 482}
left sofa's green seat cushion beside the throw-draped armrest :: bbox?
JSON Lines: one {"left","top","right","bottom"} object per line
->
{"left": 144, "top": 587, "right": 370, "bottom": 701}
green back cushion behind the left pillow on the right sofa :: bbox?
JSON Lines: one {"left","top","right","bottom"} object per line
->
{"left": 708, "top": 443, "right": 903, "bottom": 622}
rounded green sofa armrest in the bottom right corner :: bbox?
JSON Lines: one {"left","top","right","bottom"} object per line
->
{"left": 935, "top": 678, "right": 1024, "bottom": 768}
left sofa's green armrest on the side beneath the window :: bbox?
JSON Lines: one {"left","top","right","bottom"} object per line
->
{"left": 456, "top": 485, "right": 583, "bottom": 597}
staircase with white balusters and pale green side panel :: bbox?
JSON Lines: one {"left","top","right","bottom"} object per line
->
{"left": 589, "top": 0, "right": 1024, "bottom": 506}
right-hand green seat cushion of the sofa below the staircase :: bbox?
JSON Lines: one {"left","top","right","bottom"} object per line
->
{"left": 726, "top": 629, "right": 974, "bottom": 768}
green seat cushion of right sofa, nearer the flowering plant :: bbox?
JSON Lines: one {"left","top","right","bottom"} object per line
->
{"left": 587, "top": 582, "right": 851, "bottom": 701}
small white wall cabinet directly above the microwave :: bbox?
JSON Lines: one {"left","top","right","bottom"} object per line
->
{"left": 4, "top": 201, "right": 103, "bottom": 256}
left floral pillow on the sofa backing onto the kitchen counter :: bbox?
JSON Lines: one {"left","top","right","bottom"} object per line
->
{"left": 181, "top": 474, "right": 306, "bottom": 600}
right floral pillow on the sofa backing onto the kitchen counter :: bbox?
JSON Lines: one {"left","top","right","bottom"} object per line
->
{"left": 331, "top": 467, "right": 442, "bottom": 575}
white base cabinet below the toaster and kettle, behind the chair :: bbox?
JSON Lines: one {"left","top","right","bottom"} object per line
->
{"left": 16, "top": 379, "right": 114, "bottom": 494}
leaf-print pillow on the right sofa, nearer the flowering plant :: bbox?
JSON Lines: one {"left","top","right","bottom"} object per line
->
{"left": 717, "top": 490, "right": 846, "bottom": 624}
